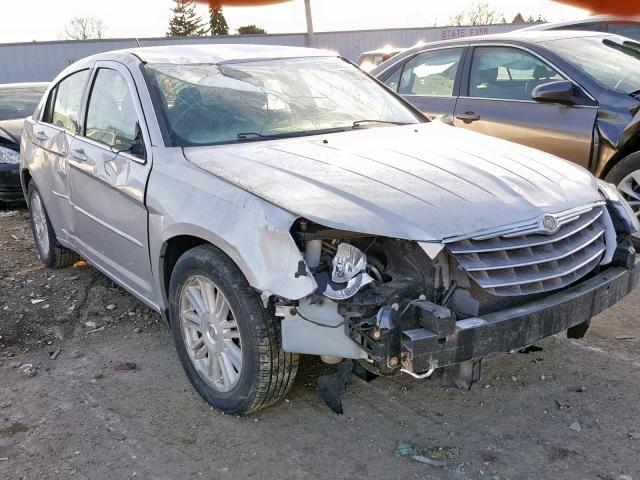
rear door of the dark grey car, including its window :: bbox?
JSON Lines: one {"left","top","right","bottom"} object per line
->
{"left": 384, "top": 46, "right": 466, "bottom": 124}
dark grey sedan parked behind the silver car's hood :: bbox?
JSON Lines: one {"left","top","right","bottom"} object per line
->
{"left": 371, "top": 31, "right": 640, "bottom": 216}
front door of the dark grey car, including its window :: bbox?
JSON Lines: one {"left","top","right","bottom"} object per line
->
{"left": 454, "top": 46, "right": 598, "bottom": 167}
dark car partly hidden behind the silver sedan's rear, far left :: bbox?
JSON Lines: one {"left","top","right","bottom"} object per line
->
{"left": 0, "top": 83, "right": 48, "bottom": 205}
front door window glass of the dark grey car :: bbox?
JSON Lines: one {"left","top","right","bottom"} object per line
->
{"left": 469, "top": 47, "right": 564, "bottom": 100}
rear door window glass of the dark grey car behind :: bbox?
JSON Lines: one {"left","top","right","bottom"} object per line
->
{"left": 392, "top": 48, "right": 464, "bottom": 97}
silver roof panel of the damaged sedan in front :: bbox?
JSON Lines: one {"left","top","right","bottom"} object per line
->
{"left": 113, "top": 43, "right": 338, "bottom": 63}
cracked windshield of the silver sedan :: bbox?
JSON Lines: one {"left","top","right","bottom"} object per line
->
{"left": 146, "top": 57, "right": 419, "bottom": 146}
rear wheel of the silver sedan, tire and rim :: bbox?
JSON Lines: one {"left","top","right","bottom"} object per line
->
{"left": 27, "top": 182, "right": 80, "bottom": 269}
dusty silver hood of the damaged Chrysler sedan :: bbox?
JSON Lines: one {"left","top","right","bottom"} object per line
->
{"left": 184, "top": 122, "right": 601, "bottom": 241}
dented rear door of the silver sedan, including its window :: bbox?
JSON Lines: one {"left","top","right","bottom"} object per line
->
{"left": 29, "top": 70, "right": 89, "bottom": 240}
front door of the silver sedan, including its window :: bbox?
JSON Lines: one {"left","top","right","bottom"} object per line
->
{"left": 69, "top": 61, "right": 153, "bottom": 300}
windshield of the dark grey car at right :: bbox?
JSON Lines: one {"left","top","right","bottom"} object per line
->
{"left": 548, "top": 36, "right": 640, "bottom": 93}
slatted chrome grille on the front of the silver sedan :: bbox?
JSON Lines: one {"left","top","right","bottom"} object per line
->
{"left": 447, "top": 206, "right": 606, "bottom": 296}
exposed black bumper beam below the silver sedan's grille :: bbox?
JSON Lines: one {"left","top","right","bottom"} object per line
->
{"left": 401, "top": 257, "right": 640, "bottom": 373}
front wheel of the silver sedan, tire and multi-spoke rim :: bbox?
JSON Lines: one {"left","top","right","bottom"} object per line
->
{"left": 169, "top": 245, "right": 298, "bottom": 415}
